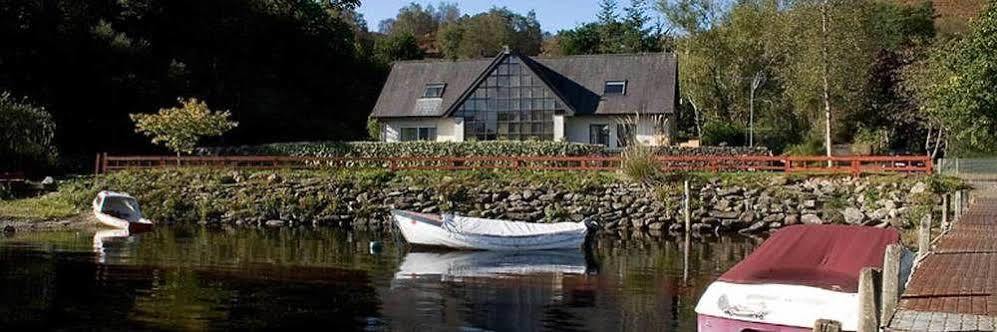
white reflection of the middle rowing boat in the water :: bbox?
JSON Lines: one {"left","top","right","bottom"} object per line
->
{"left": 395, "top": 250, "right": 586, "bottom": 280}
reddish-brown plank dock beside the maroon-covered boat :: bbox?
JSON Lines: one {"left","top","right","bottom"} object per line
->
{"left": 886, "top": 194, "right": 997, "bottom": 331}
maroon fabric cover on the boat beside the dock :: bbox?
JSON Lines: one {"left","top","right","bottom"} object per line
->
{"left": 720, "top": 225, "right": 900, "bottom": 293}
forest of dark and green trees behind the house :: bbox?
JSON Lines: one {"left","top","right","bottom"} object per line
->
{"left": 0, "top": 0, "right": 997, "bottom": 168}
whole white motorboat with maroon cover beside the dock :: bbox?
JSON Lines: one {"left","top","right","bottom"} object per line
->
{"left": 696, "top": 225, "right": 913, "bottom": 332}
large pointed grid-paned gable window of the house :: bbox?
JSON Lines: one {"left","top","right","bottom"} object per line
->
{"left": 456, "top": 56, "right": 563, "bottom": 141}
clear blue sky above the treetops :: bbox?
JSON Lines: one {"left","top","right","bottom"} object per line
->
{"left": 360, "top": 0, "right": 644, "bottom": 32}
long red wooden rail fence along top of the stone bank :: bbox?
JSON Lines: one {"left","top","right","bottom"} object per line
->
{"left": 94, "top": 154, "right": 933, "bottom": 175}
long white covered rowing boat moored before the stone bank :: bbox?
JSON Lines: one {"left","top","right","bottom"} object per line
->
{"left": 391, "top": 210, "right": 588, "bottom": 250}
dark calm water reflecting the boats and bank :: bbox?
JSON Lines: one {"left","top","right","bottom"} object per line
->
{"left": 0, "top": 228, "right": 760, "bottom": 331}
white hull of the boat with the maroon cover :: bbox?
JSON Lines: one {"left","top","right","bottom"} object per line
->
{"left": 696, "top": 281, "right": 859, "bottom": 331}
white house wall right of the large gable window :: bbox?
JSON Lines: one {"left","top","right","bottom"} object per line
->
{"left": 555, "top": 115, "right": 675, "bottom": 148}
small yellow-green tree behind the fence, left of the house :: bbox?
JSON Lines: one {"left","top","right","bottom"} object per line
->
{"left": 130, "top": 98, "right": 239, "bottom": 158}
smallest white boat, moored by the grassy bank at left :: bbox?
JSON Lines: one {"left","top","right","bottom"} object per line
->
{"left": 93, "top": 191, "right": 152, "bottom": 233}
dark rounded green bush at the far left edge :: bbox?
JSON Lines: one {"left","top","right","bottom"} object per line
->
{"left": 0, "top": 91, "right": 58, "bottom": 171}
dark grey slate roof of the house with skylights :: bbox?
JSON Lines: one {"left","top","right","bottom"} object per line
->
{"left": 373, "top": 53, "right": 678, "bottom": 117}
